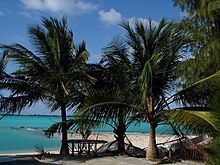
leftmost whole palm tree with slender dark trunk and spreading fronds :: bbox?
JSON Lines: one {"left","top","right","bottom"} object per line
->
{"left": 1, "top": 18, "right": 89, "bottom": 154}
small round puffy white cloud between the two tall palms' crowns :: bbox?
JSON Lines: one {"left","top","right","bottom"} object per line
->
{"left": 99, "top": 8, "right": 122, "bottom": 25}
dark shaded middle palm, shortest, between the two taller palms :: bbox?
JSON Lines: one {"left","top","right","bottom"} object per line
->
{"left": 74, "top": 56, "right": 136, "bottom": 154}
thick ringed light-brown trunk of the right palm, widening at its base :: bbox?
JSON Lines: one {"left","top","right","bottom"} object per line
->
{"left": 146, "top": 123, "right": 159, "bottom": 160}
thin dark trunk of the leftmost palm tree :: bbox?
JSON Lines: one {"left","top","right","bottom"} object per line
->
{"left": 60, "top": 104, "right": 69, "bottom": 154}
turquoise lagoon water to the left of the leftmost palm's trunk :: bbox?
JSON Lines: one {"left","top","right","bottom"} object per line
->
{"left": 0, "top": 116, "right": 60, "bottom": 154}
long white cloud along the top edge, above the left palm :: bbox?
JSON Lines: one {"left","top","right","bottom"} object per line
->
{"left": 20, "top": 0, "right": 97, "bottom": 15}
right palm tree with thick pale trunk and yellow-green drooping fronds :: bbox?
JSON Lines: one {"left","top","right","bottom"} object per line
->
{"left": 77, "top": 19, "right": 220, "bottom": 159}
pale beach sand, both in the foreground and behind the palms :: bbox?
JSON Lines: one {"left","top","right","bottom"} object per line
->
{"left": 0, "top": 132, "right": 205, "bottom": 165}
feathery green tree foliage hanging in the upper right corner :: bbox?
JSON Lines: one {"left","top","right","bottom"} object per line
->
{"left": 173, "top": 0, "right": 220, "bottom": 84}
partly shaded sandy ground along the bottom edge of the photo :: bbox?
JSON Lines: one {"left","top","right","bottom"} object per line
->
{"left": 0, "top": 155, "right": 205, "bottom": 165}
